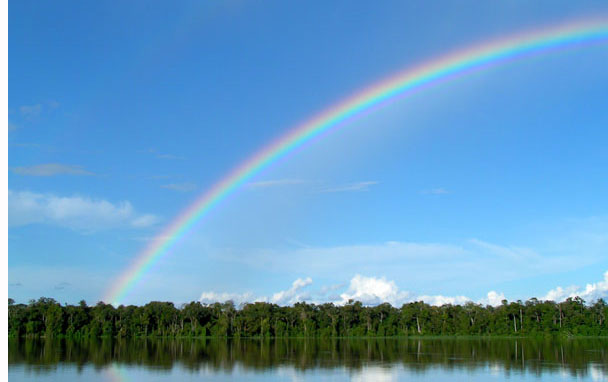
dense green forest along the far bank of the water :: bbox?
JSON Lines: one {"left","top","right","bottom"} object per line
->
{"left": 8, "top": 297, "right": 608, "bottom": 338}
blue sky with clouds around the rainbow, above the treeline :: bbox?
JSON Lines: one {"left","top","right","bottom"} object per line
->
{"left": 8, "top": 0, "right": 608, "bottom": 305}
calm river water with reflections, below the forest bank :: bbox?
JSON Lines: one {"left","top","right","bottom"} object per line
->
{"left": 8, "top": 339, "right": 608, "bottom": 382}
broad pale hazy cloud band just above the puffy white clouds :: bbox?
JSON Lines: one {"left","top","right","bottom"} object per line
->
{"left": 214, "top": 233, "right": 608, "bottom": 296}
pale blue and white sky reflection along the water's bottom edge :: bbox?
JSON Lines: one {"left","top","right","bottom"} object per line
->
{"left": 8, "top": 363, "right": 608, "bottom": 382}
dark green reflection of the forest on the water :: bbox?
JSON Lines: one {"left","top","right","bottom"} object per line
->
{"left": 8, "top": 338, "right": 608, "bottom": 376}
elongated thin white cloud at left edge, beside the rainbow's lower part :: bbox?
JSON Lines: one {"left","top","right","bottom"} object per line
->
{"left": 8, "top": 190, "right": 158, "bottom": 231}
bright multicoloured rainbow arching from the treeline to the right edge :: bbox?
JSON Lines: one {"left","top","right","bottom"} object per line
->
{"left": 103, "top": 19, "right": 608, "bottom": 304}
